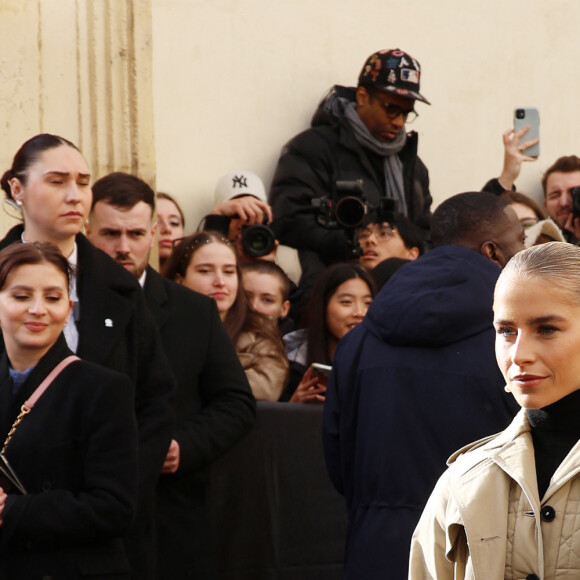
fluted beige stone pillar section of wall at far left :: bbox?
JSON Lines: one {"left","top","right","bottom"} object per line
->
{"left": 0, "top": 0, "right": 155, "bottom": 237}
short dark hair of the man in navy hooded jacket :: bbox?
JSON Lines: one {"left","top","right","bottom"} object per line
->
{"left": 431, "top": 191, "right": 508, "bottom": 248}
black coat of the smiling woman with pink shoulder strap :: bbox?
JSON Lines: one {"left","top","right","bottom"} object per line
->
{"left": 0, "top": 335, "right": 137, "bottom": 580}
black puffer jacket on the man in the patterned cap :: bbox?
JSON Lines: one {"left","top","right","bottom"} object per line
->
{"left": 270, "top": 86, "right": 431, "bottom": 270}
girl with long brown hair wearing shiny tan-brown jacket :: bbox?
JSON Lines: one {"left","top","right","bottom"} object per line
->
{"left": 163, "top": 231, "right": 288, "bottom": 401}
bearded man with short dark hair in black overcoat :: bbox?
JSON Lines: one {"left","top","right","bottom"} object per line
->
{"left": 87, "top": 173, "right": 255, "bottom": 579}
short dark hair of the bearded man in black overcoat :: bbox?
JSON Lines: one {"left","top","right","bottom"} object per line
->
{"left": 91, "top": 171, "right": 155, "bottom": 213}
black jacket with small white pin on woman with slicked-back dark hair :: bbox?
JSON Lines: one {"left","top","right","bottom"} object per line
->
{"left": 0, "top": 225, "right": 174, "bottom": 580}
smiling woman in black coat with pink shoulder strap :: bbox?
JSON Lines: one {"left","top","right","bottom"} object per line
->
{"left": 0, "top": 243, "right": 138, "bottom": 580}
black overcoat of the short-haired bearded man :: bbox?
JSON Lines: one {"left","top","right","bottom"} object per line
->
{"left": 144, "top": 268, "right": 256, "bottom": 580}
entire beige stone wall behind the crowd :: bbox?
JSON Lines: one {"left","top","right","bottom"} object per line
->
{"left": 0, "top": 0, "right": 580, "bottom": 238}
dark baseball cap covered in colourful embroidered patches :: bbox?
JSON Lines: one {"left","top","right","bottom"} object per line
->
{"left": 358, "top": 48, "right": 431, "bottom": 105}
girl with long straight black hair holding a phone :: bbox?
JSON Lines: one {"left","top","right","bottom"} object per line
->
{"left": 280, "top": 263, "right": 375, "bottom": 403}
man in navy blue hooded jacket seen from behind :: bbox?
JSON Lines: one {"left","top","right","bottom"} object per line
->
{"left": 323, "top": 193, "right": 524, "bottom": 580}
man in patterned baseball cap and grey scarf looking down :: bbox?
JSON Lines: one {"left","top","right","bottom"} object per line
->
{"left": 270, "top": 49, "right": 431, "bottom": 292}
